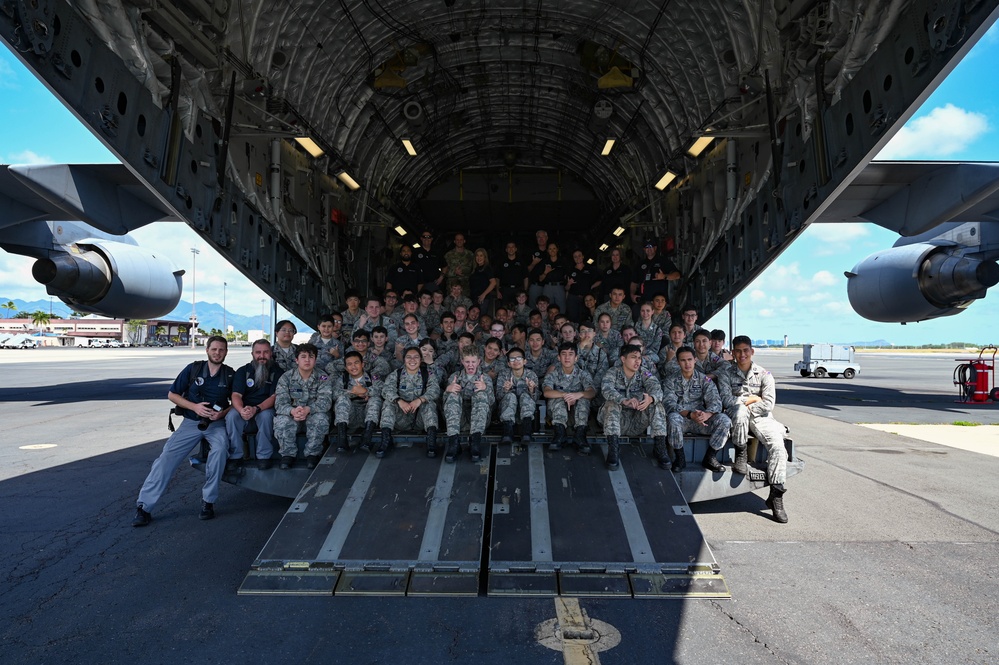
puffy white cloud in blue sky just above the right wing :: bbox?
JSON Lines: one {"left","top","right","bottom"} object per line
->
{"left": 877, "top": 104, "right": 989, "bottom": 159}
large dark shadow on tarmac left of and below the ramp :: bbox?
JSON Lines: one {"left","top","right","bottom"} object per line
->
{"left": 0, "top": 439, "right": 696, "bottom": 665}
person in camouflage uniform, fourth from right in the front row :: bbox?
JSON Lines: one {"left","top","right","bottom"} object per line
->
{"left": 541, "top": 342, "right": 597, "bottom": 455}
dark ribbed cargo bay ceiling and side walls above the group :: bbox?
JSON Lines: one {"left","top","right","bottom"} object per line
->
{"left": 0, "top": 0, "right": 999, "bottom": 321}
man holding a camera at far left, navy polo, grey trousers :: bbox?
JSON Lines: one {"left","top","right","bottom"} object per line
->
{"left": 132, "top": 335, "right": 235, "bottom": 526}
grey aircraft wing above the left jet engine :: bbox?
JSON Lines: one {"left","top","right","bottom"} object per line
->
{"left": 0, "top": 164, "right": 181, "bottom": 235}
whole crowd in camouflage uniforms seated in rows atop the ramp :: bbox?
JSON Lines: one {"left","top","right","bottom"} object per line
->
{"left": 135, "top": 232, "right": 787, "bottom": 526}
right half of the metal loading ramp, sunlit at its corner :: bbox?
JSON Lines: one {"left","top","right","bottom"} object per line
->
{"left": 487, "top": 444, "right": 730, "bottom": 597}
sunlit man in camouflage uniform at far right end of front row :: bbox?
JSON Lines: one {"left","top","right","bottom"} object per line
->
{"left": 726, "top": 335, "right": 787, "bottom": 524}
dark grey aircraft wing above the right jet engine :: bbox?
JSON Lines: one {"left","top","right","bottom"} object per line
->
{"left": 816, "top": 162, "right": 999, "bottom": 236}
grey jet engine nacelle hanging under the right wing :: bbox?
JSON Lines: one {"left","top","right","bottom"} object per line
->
{"left": 846, "top": 243, "right": 999, "bottom": 323}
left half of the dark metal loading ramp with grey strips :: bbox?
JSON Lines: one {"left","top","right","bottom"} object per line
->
{"left": 239, "top": 446, "right": 489, "bottom": 596}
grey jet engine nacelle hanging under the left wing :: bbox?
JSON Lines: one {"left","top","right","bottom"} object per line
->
{"left": 31, "top": 239, "right": 184, "bottom": 319}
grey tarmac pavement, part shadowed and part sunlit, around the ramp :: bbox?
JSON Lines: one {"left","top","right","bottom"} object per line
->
{"left": 0, "top": 349, "right": 999, "bottom": 664}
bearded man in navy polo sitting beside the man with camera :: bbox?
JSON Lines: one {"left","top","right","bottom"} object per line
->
{"left": 225, "top": 339, "right": 282, "bottom": 471}
